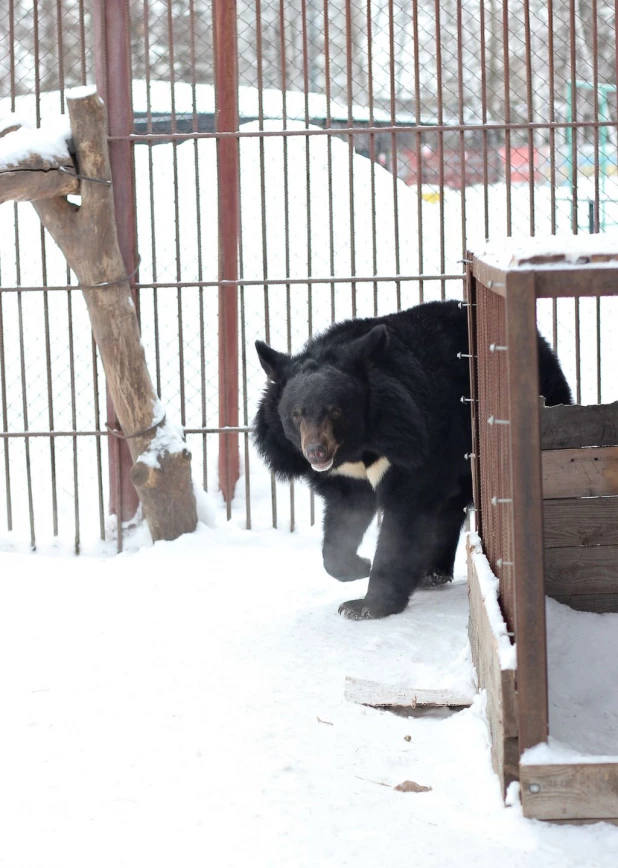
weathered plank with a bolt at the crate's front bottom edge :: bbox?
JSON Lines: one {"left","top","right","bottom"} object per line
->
{"left": 519, "top": 762, "right": 618, "bottom": 820}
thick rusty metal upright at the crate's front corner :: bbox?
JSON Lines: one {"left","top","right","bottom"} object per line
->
{"left": 506, "top": 272, "right": 548, "bottom": 752}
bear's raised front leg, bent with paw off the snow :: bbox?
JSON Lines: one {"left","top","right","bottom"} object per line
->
{"left": 321, "top": 480, "right": 376, "bottom": 582}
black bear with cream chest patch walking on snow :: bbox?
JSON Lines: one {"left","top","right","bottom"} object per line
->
{"left": 254, "top": 301, "right": 571, "bottom": 619}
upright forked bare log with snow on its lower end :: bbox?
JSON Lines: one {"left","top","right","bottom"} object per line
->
{"left": 0, "top": 88, "right": 197, "bottom": 540}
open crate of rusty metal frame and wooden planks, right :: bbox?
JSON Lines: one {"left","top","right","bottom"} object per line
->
{"left": 467, "top": 239, "right": 618, "bottom": 822}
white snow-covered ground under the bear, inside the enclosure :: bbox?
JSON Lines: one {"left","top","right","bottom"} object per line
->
{"left": 0, "top": 523, "right": 618, "bottom": 868}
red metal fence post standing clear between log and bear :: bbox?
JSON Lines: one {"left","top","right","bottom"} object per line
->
{"left": 213, "top": 0, "right": 240, "bottom": 502}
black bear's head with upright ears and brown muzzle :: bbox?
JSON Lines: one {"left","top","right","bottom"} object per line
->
{"left": 255, "top": 325, "right": 388, "bottom": 472}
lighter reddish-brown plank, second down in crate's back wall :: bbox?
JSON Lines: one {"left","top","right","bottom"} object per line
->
{"left": 543, "top": 446, "right": 618, "bottom": 499}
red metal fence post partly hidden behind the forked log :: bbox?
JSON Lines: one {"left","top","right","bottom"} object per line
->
{"left": 92, "top": 0, "right": 139, "bottom": 521}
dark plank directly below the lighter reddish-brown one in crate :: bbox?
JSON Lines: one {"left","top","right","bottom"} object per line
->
{"left": 543, "top": 497, "right": 618, "bottom": 549}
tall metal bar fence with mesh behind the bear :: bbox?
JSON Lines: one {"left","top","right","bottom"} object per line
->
{"left": 0, "top": 0, "right": 618, "bottom": 550}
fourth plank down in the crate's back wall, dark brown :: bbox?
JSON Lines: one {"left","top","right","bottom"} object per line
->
{"left": 545, "top": 546, "right": 618, "bottom": 597}
